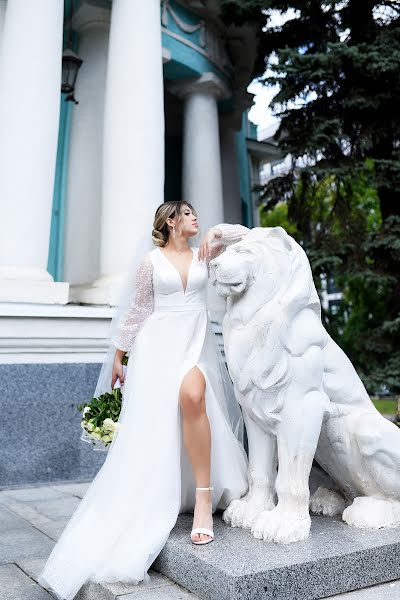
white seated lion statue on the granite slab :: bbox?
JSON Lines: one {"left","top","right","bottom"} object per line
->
{"left": 210, "top": 227, "right": 400, "bottom": 543}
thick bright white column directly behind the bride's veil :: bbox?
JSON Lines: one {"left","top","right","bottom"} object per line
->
{"left": 77, "top": 0, "right": 164, "bottom": 304}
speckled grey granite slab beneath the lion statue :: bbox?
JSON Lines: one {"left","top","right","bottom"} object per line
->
{"left": 153, "top": 512, "right": 400, "bottom": 600}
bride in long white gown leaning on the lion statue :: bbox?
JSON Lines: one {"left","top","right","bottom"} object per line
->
{"left": 39, "top": 202, "right": 248, "bottom": 600}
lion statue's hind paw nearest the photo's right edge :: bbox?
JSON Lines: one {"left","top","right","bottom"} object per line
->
{"left": 342, "top": 496, "right": 400, "bottom": 529}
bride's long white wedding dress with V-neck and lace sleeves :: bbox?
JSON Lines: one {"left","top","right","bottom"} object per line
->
{"left": 39, "top": 224, "right": 248, "bottom": 600}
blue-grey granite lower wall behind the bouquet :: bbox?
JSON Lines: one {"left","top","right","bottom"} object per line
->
{"left": 0, "top": 363, "right": 106, "bottom": 488}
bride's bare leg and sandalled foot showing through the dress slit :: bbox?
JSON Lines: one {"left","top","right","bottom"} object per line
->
{"left": 179, "top": 367, "right": 212, "bottom": 542}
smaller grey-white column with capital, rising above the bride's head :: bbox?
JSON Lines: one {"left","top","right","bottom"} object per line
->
{"left": 170, "top": 73, "right": 230, "bottom": 233}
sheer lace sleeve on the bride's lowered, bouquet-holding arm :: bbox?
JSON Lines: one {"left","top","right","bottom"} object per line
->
{"left": 111, "top": 255, "right": 154, "bottom": 352}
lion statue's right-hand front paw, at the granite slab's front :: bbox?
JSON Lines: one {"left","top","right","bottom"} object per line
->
{"left": 251, "top": 508, "right": 311, "bottom": 544}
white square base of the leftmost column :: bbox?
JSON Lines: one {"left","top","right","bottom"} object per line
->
{"left": 0, "top": 279, "right": 69, "bottom": 304}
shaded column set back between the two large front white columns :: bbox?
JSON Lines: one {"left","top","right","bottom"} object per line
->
{"left": 64, "top": 3, "right": 111, "bottom": 288}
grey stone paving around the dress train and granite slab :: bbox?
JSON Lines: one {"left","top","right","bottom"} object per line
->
{"left": 0, "top": 483, "right": 400, "bottom": 600}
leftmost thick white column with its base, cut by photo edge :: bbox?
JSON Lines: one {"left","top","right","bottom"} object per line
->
{"left": 0, "top": 0, "right": 68, "bottom": 304}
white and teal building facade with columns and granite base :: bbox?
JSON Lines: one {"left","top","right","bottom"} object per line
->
{"left": 0, "top": 0, "right": 259, "bottom": 485}
